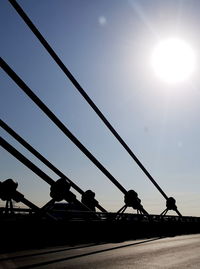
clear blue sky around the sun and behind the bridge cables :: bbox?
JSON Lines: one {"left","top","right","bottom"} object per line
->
{"left": 0, "top": 0, "right": 200, "bottom": 216}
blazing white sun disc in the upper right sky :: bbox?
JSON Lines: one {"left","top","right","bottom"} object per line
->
{"left": 151, "top": 38, "right": 195, "bottom": 84}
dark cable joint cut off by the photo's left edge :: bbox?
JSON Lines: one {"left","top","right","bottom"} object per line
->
{"left": 0, "top": 178, "right": 18, "bottom": 201}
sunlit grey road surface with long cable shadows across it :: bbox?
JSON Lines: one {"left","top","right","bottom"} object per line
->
{"left": 0, "top": 231, "right": 200, "bottom": 269}
